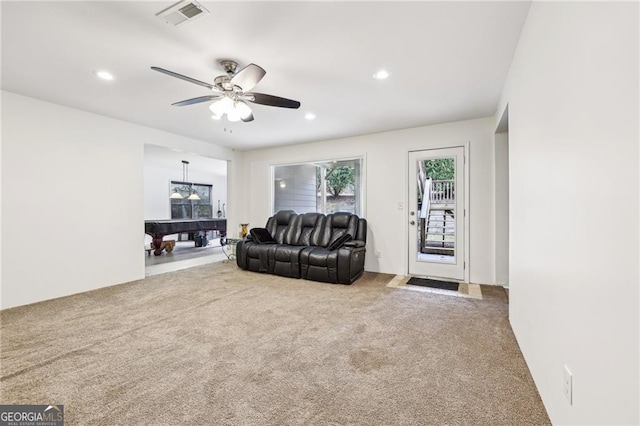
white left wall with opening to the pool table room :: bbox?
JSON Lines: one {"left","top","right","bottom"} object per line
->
{"left": 0, "top": 91, "right": 235, "bottom": 308}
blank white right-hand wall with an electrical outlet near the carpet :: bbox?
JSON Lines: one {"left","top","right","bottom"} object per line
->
{"left": 496, "top": 2, "right": 640, "bottom": 425}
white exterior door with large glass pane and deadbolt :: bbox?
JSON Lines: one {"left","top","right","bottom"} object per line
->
{"left": 407, "top": 147, "right": 465, "bottom": 281}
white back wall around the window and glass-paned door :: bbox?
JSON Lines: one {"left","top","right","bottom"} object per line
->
{"left": 239, "top": 119, "right": 495, "bottom": 283}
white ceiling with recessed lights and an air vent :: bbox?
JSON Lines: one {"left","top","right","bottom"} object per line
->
{"left": 1, "top": 1, "right": 529, "bottom": 150}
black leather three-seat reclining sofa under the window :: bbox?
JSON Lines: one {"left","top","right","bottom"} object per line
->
{"left": 236, "top": 210, "right": 367, "bottom": 284}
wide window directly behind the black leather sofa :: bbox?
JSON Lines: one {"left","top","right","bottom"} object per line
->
{"left": 272, "top": 158, "right": 363, "bottom": 216}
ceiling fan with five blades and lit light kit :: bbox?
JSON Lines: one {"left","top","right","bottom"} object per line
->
{"left": 151, "top": 60, "right": 300, "bottom": 122}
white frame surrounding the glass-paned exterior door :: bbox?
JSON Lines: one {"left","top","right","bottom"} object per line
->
{"left": 404, "top": 141, "right": 471, "bottom": 283}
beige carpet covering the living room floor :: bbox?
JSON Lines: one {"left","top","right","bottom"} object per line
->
{"left": 0, "top": 263, "right": 549, "bottom": 425}
